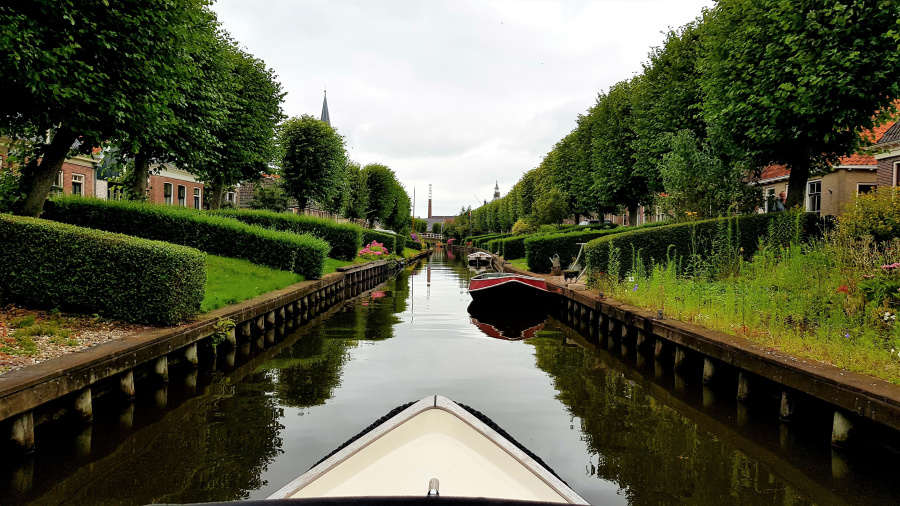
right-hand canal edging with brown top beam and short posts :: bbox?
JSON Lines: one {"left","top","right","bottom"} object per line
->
{"left": 482, "top": 249, "right": 900, "bottom": 448}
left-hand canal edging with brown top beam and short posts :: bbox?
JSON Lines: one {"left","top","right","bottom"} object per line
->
{"left": 0, "top": 250, "right": 433, "bottom": 453}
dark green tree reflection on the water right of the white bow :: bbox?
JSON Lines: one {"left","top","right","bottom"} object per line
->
{"left": 526, "top": 330, "right": 807, "bottom": 504}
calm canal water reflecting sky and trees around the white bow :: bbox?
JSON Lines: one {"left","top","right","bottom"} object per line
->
{"left": 0, "top": 250, "right": 900, "bottom": 505}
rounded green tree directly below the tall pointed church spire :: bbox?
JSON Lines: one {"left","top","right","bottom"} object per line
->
{"left": 278, "top": 114, "right": 347, "bottom": 209}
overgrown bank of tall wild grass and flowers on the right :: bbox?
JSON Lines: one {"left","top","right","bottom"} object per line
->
{"left": 591, "top": 236, "right": 900, "bottom": 384}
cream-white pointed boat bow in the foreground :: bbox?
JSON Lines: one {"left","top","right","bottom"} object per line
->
{"left": 269, "top": 395, "right": 587, "bottom": 504}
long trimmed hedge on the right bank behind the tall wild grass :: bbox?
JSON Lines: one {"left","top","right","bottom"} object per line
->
{"left": 585, "top": 212, "right": 821, "bottom": 277}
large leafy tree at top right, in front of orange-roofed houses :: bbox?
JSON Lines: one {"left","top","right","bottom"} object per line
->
{"left": 702, "top": 0, "right": 900, "bottom": 207}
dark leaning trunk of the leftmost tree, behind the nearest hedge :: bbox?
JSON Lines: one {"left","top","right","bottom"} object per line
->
{"left": 20, "top": 127, "right": 78, "bottom": 218}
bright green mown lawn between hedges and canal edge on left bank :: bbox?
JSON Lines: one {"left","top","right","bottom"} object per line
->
{"left": 200, "top": 255, "right": 353, "bottom": 313}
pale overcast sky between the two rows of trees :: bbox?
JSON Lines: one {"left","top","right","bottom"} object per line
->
{"left": 213, "top": 0, "right": 713, "bottom": 217}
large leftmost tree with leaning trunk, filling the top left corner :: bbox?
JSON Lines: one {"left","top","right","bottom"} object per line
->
{"left": 0, "top": 0, "right": 213, "bottom": 216}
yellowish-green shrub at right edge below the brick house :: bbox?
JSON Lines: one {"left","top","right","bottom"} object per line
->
{"left": 838, "top": 186, "right": 900, "bottom": 241}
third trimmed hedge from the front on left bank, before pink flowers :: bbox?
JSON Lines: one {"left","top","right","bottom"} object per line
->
{"left": 209, "top": 209, "right": 363, "bottom": 260}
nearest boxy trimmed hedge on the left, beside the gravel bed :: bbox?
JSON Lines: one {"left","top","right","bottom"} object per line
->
{"left": 0, "top": 215, "right": 206, "bottom": 325}
